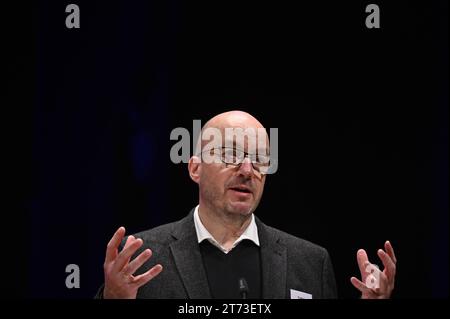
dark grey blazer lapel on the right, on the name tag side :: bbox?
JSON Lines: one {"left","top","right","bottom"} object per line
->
{"left": 256, "top": 218, "right": 287, "bottom": 299}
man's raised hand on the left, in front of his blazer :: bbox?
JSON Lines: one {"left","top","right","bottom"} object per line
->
{"left": 103, "top": 227, "right": 162, "bottom": 299}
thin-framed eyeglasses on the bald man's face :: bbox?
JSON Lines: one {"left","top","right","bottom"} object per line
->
{"left": 201, "top": 147, "right": 270, "bottom": 175}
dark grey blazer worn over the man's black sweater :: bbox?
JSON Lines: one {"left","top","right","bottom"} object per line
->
{"left": 96, "top": 210, "right": 337, "bottom": 299}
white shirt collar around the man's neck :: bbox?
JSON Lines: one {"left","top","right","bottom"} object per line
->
{"left": 194, "top": 205, "right": 259, "bottom": 254}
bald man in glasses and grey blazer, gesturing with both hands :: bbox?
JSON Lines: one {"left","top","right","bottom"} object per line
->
{"left": 97, "top": 111, "right": 396, "bottom": 299}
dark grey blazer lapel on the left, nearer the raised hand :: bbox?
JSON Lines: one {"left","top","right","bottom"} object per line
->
{"left": 170, "top": 211, "right": 211, "bottom": 299}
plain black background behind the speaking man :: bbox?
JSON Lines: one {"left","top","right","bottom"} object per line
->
{"left": 2, "top": 0, "right": 448, "bottom": 298}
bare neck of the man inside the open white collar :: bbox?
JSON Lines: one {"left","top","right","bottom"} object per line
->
{"left": 198, "top": 204, "right": 252, "bottom": 249}
